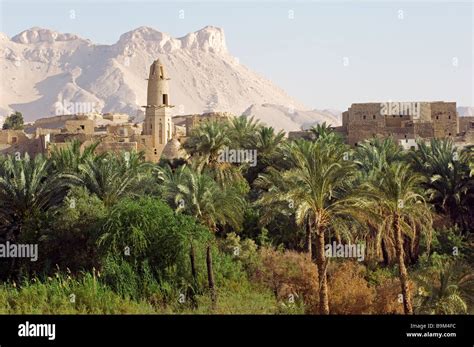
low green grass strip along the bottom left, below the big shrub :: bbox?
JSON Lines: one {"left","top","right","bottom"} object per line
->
{"left": 0, "top": 273, "right": 288, "bottom": 314}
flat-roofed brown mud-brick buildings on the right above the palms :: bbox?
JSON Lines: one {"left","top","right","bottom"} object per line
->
{"left": 288, "top": 101, "right": 474, "bottom": 149}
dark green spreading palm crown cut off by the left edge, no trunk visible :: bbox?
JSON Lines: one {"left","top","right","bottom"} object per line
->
{"left": 0, "top": 154, "right": 77, "bottom": 245}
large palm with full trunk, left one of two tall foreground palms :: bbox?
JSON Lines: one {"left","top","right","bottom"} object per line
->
{"left": 257, "top": 138, "right": 355, "bottom": 314}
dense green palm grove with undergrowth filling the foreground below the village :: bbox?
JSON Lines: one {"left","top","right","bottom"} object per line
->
{"left": 0, "top": 117, "right": 474, "bottom": 314}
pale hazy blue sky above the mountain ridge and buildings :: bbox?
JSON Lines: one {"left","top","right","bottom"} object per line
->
{"left": 0, "top": 0, "right": 474, "bottom": 110}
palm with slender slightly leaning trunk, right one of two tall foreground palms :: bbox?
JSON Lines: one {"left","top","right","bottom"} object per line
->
{"left": 358, "top": 162, "right": 432, "bottom": 314}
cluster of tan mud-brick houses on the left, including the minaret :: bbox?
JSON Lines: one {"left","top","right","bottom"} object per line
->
{"left": 0, "top": 60, "right": 232, "bottom": 163}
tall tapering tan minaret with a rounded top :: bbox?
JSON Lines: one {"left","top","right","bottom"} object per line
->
{"left": 143, "top": 59, "right": 173, "bottom": 162}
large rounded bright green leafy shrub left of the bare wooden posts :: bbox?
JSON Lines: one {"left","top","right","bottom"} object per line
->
{"left": 98, "top": 197, "right": 211, "bottom": 304}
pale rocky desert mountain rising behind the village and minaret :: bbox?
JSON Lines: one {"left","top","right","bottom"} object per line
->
{"left": 0, "top": 26, "right": 332, "bottom": 130}
